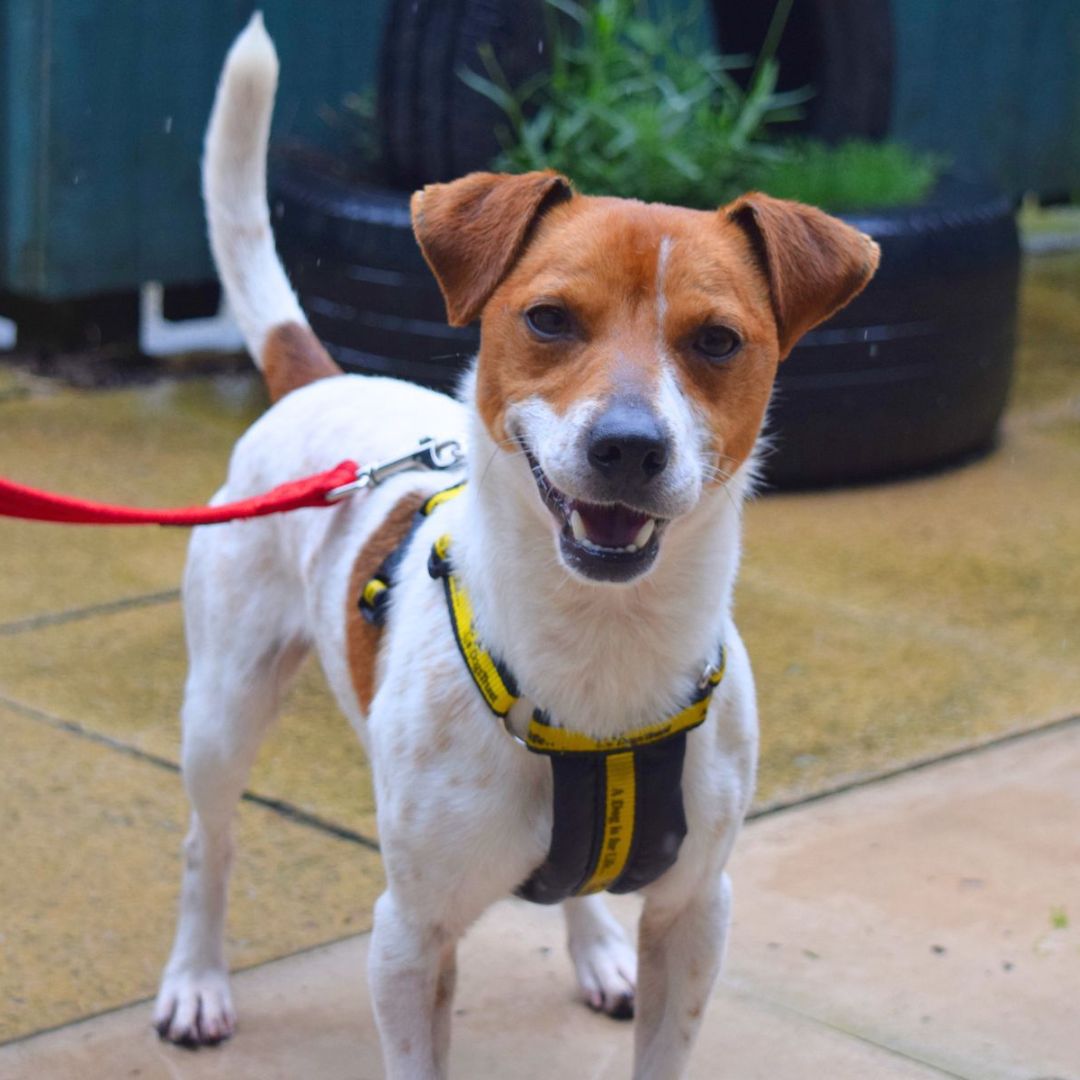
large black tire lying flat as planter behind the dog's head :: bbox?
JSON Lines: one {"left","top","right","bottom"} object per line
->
{"left": 272, "top": 162, "right": 1020, "bottom": 487}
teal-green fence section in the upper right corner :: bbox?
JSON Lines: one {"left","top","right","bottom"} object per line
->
{"left": 892, "top": 0, "right": 1080, "bottom": 194}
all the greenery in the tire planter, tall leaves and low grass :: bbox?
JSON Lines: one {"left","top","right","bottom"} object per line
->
{"left": 459, "top": 0, "right": 936, "bottom": 208}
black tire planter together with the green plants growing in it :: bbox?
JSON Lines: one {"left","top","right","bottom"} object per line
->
{"left": 273, "top": 0, "right": 1018, "bottom": 486}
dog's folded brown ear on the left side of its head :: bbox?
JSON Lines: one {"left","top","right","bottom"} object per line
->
{"left": 411, "top": 172, "right": 573, "bottom": 326}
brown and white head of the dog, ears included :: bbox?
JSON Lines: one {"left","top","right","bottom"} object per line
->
{"left": 413, "top": 173, "right": 878, "bottom": 581}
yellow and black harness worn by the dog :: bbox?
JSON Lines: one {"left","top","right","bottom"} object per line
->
{"left": 360, "top": 484, "right": 725, "bottom": 904}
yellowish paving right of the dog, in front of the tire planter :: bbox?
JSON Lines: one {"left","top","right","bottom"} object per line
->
{"left": 737, "top": 253, "right": 1080, "bottom": 805}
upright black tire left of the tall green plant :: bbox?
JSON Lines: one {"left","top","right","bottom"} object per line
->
{"left": 379, "top": 0, "right": 546, "bottom": 188}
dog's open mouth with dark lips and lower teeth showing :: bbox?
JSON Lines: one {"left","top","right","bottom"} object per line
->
{"left": 525, "top": 448, "right": 667, "bottom": 581}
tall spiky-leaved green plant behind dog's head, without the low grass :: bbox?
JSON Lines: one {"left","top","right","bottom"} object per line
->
{"left": 461, "top": 0, "right": 809, "bottom": 205}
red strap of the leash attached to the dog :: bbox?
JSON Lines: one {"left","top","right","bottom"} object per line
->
{"left": 0, "top": 461, "right": 360, "bottom": 525}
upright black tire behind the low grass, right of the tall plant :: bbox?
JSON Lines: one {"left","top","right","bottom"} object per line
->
{"left": 712, "top": 0, "right": 893, "bottom": 141}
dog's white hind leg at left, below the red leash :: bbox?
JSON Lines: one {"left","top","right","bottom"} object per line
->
{"left": 154, "top": 523, "right": 307, "bottom": 1044}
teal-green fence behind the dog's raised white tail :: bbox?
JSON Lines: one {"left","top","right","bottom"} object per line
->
{"left": 0, "top": 0, "right": 388, "bottom": 300}
